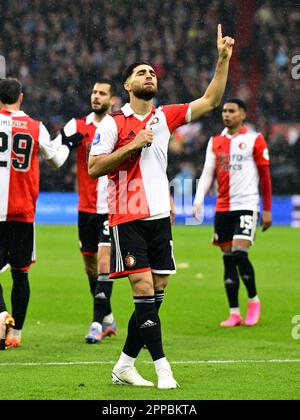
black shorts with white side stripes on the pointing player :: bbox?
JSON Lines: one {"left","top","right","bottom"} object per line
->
{"left": 109, "top": 217, "right": 176, "bottom": 278}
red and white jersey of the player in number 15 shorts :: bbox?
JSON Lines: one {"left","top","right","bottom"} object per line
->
{"left": 205, "top": 127, "right": 270, "bottom": 212}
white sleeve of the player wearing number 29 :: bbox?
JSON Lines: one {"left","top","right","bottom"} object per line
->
{"left": 39, "top": 123, "right": 70, "bottom": 168}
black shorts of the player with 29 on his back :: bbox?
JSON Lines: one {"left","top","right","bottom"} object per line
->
{"left": 0, "top": 222, "right": 35, "bottom": 271}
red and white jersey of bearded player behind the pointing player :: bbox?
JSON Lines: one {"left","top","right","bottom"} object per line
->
{"left": 54, "top": 112, "right": 108, "bottom": 214}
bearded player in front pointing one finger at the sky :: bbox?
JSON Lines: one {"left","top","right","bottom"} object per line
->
{"left": 89, "top": 25, "right": 234, "bottom": 389}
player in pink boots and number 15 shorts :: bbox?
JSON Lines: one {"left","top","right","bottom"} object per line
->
{"left": 193, "top": 99, "right": 272, "bottom": 327}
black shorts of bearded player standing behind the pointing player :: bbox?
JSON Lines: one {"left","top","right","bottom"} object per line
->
{"left": 78, "top": 212, "right": 110, "bottom": 255}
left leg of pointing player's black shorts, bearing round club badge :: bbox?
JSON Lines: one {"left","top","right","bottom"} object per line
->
{"left": 110, "top": 221, "right": 151, "bottom": 278}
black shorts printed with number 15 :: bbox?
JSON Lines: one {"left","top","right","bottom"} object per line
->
{"left": 213, "top": 210, "right": 259, "bottom": 246}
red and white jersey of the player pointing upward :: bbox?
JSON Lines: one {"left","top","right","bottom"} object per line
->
{"left": 90, "top": 104, "right": 191, "bottom": 226}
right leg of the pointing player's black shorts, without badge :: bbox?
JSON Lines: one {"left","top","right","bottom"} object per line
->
{"left": 142, "top": 217, "right": 176, "bottom": 276}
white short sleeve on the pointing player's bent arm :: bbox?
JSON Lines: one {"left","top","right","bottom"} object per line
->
{"left": 90, "top": 115, "right": 118, "bottom": 156}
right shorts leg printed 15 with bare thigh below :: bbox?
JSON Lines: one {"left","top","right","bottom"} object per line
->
{"left": 233, "top": 210, "right": 258, "bottom": 248}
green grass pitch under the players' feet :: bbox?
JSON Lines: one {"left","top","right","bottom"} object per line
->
{"left": 0, "top": 226, "right": 300, "bottom": 400}
